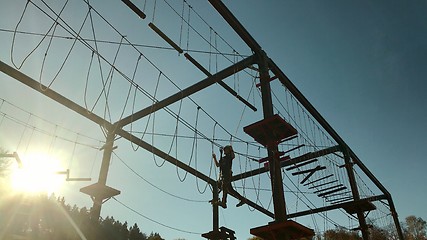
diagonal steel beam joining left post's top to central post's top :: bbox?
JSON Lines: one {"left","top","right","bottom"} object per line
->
{"left": 115, "top": 56, "right": 255, "bottom": 128}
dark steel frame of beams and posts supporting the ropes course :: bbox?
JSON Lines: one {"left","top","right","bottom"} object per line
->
{"left": 0, "top": 0, "right": 403, "bottom": 240}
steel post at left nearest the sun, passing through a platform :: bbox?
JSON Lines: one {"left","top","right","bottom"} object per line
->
{"left": 91, "top": 130, "right": 116, "bottom": 220}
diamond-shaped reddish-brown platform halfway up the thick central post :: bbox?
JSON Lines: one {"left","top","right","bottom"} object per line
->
{"left": 243, "top": 114, "right": 298, "bottom": 147}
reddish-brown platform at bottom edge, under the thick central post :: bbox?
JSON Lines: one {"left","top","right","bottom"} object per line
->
{"left": 251, "top": 220, "right": 315, "bottom": 240}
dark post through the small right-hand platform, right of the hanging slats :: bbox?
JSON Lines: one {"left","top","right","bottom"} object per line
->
{"left": 343, "top": 146, "right": 369, "bottom": 240}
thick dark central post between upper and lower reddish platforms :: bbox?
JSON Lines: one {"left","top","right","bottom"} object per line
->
{"left": 258, "top": 52, "right": 287, "bottom": 222}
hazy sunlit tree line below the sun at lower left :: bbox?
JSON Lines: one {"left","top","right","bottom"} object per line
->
{"left": 0, "top": 195, "right": 163, "bottom": 240}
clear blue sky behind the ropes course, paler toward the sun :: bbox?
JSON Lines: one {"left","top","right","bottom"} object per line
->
{"left": 0, "top": 0, "right": 427, "bottom": 240}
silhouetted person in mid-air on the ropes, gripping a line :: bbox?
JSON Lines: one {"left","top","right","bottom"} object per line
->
{"left": 212, "top": 145, "right": 245, "bottom": 208}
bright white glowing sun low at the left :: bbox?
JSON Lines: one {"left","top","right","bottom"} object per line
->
{"left": 11, "top": 153, "right": 64, "bottom": 194}
